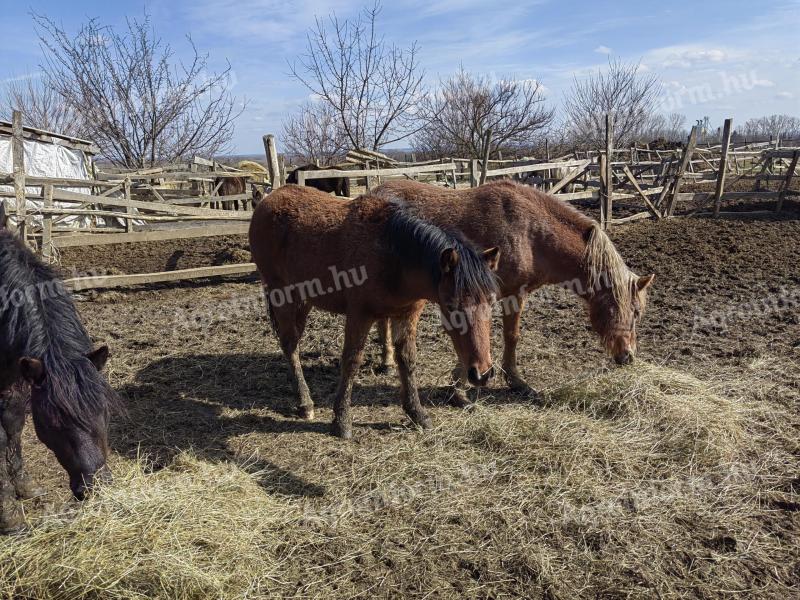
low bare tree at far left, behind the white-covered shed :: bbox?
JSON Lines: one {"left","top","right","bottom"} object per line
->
{"left": 0, "top": 73, "right": 87, "bottom": 137}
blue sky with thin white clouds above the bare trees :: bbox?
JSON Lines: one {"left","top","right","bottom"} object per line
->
{"left": 0, "top": 0, "right": 800, "bottom": 153}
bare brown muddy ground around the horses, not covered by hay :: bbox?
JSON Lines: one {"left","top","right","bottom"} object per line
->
{"left": 12, "top": 200, "right": 800, "bottom": 597}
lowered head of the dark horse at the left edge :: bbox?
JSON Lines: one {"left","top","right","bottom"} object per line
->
{"left": 19, "top": 346, "right": 116, "bottom": 500}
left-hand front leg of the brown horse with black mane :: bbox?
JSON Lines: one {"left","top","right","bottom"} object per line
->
{"left": 331, "top": 314, "right": 374, "bottom": 440}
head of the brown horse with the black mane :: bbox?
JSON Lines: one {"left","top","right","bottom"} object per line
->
{"left": 437, "top": 248, "right": 500, "bottom": 386}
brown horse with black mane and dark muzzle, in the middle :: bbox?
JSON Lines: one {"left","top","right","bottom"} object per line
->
{"left": 250, "top": 185, "right": 499, "bottom": 438}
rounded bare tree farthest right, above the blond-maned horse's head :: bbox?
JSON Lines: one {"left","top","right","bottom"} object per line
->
{"left": 564, "top": 59, "right": 661, "bottom": 148}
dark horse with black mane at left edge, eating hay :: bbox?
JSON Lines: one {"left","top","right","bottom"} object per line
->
{"left": 0, "top": 205, "right": 118, "bottom": 533}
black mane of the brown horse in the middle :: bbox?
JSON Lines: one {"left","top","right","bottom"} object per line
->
{"left": 385, "top": 198, "right": 497, "bottom": 301}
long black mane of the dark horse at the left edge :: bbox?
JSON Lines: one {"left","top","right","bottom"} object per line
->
{"left": 0, "top": 229, "right": 118, "bottom": 429}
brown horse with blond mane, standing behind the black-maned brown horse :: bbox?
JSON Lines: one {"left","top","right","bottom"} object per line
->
{"left": 374, "top": 181, "right": 654, "bottom": 402}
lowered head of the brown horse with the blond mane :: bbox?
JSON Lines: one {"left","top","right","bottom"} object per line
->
{"left": 589, "top": 275, "right": 655, "bottom": 365}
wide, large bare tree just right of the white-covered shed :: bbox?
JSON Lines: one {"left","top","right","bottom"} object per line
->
{"left": 34, "top": 15, "right": 241, "bottom": 168}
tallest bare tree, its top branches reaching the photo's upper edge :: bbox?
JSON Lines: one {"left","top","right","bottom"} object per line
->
{"left": 289, "top": 3, "right": 424, "bottom": 150}
